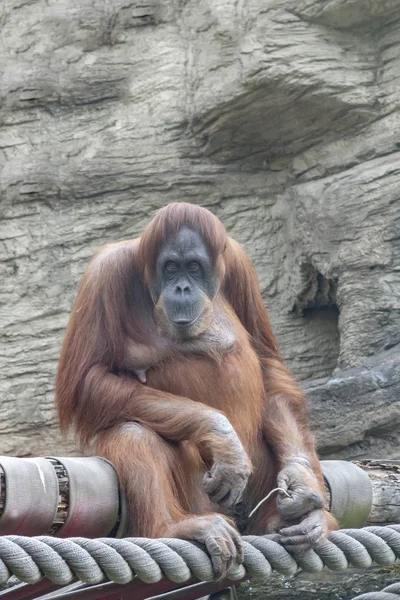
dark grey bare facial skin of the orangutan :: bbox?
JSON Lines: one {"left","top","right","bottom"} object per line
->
{"left": 154, "top": 228, "right": 218, "bottom": 337}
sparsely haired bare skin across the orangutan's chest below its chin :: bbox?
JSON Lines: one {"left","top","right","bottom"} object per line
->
{"left": 127, "top": 309, "right": 236, "bottom": 384}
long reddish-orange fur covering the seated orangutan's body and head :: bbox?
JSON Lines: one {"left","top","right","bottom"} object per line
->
{"left": 56, "top": 203, "right": 334, "bottom": 537}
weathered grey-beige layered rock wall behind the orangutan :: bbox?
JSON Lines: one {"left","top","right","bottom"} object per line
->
{"left": 0, "top": 0, "right": 400, "bottom": 457}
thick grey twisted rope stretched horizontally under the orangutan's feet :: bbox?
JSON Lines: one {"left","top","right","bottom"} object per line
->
{"left": 0, "top": 525, "right": 400, "bottom": 584}
